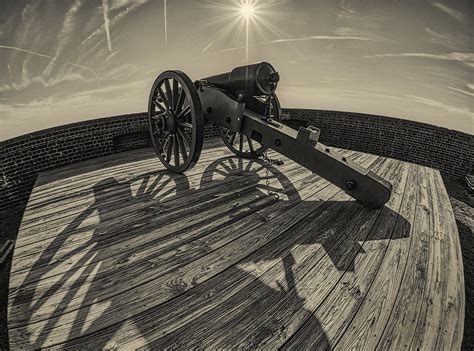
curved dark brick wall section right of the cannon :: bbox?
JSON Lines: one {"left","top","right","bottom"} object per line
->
{"left": 284, "top": 109, "right": 474, "bottom": 178}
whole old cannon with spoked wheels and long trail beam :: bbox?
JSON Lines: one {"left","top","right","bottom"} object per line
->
{"left": 148, "top": 62, "right": 392, "bottom": 208}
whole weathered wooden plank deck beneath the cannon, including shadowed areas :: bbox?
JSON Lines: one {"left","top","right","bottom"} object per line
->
{"left": 9, "top": 140, "right": 464, "bottom": 350}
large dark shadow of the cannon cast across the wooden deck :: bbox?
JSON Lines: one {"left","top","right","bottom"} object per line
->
{"left": 10, "top": 157, "right": 410, "bottom": 349}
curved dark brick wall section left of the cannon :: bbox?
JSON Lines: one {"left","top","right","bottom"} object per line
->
{"left": 0, "top": 113, "right": 218, "bottom": 209}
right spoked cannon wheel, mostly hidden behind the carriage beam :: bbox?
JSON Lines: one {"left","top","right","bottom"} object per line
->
{"left": 219, "top": 94, "right": 281, "bottom": 158}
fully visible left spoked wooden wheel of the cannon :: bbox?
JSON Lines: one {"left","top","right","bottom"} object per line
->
{"left": 148, "top": 71, "right": 204, "bottom": 173}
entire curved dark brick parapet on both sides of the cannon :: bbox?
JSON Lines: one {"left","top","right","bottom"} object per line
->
{"left": 0, "top": 109, "right": 474, "bottom": 208}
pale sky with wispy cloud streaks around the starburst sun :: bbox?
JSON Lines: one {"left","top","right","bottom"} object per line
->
{"left": 0, "top": 0, "right": 474, "bottom": 140}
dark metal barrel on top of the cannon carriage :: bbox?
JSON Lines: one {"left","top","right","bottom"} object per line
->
{"left": 202, "top": 62, "right": 280, "bottom": 98}
